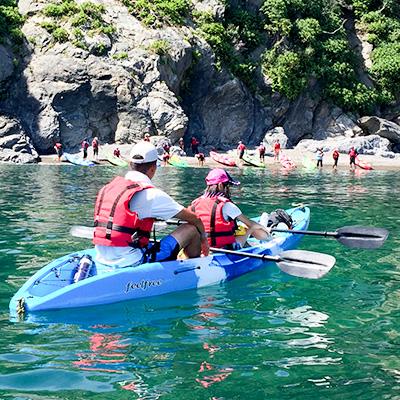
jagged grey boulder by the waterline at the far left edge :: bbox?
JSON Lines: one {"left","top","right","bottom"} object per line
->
{"left": 0, "top": 115, "right": 39, "bottom": 164}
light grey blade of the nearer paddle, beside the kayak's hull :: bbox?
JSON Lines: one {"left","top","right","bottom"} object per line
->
{"left": 277, "top": 250, "right": 336, "bottom": 279}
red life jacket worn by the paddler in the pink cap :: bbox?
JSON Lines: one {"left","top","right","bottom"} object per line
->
{"left": 191, "top": 196, "right": 236, "bottom": 248}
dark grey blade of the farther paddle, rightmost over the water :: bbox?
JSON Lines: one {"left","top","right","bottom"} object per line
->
{"left": 336, "top": 226, "right": 389, "bottom": 249}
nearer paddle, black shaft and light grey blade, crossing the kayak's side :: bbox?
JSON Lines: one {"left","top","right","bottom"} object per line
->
{"left": 210, "top": 247, "right": 336, "bottom": 279}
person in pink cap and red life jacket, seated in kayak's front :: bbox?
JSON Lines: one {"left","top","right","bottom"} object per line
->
{"left": 191, "top": 168, "right": 269, "bottom": 249}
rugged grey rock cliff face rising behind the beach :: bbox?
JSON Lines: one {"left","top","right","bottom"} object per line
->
{"left": 0, "top": 0, "right": 400, "bottom": 162}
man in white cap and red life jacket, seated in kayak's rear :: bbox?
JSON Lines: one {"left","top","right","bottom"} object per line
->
{"left": 93, "top": 141, "right": 209, "bottom": 266}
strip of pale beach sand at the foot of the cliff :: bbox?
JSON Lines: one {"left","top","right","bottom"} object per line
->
{"left": 40, "top": 144, "right": 400, "bottom": 170}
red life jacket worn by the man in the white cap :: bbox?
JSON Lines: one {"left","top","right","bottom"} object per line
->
{"left": 93, "top": 176, "right": 154, "bottom": 248}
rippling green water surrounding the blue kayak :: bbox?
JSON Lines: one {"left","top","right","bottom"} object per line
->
{"left": 0, "top": 165, "right": 400, "bottom": 400}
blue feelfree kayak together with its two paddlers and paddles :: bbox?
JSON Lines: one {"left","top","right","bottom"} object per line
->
{"left": 10, "top": 141, "right": 388, "bottom": 315}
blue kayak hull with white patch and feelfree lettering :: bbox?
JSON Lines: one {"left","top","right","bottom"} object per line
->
{"left": 10, "top": 207, "right": 310, "bottom": 315}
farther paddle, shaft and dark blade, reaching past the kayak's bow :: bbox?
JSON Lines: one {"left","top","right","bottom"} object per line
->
{"left": 272, "top": 225, "right": 389, "bottom": 249}
